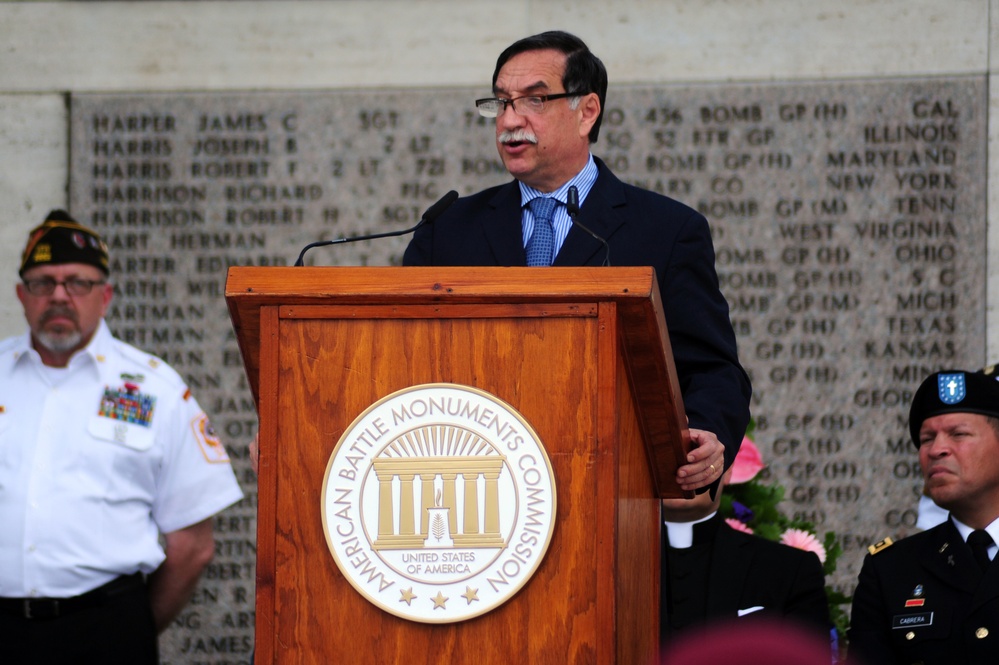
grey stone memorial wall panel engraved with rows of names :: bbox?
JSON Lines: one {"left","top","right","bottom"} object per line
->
{"left": 70, "top": 78, "right": 987, "bottom": 665}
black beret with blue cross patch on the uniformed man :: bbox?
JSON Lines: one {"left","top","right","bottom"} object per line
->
{"left": 909, "top": 366, "right": 999, "bottom": 448}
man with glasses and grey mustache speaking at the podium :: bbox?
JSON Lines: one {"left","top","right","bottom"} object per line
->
{"left": 403, "top": 31, "right": 751, "bottom": 490}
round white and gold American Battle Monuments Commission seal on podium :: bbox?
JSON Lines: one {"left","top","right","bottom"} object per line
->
{"left": 322, "top": 383, "right": 556, "bottom": 623}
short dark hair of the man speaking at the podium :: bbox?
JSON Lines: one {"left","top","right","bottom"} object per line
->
{"left": 493, "top": 30, "right": 607, "bottom": 143}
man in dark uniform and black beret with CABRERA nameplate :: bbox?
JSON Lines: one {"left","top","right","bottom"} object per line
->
{"left": 849, "top": 370, "right": 999, "bottom": 665}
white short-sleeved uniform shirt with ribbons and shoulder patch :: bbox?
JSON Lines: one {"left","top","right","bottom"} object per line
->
{"left": 0, "top": 321, "right": 243, "bottom": 598}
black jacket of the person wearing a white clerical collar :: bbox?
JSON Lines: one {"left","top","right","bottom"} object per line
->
{"left": 660, "top": 518, "right": 832, "bottom": 639}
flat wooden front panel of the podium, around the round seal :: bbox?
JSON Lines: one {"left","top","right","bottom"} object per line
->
{"left": 262, "top": 304, "right": 648, "bottom": 663}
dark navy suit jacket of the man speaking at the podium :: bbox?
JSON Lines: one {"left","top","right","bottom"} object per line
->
{"left": 403, "top": 159, "right": 751, "bottom": 466}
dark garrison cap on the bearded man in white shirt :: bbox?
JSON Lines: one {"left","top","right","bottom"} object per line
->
{"left": 18, "top": 210, "right": 110, "bottom": 277}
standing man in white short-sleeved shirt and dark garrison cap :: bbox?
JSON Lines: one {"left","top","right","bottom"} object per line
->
{"left": 0, "top": 210, "right": 242, "bottom": 665}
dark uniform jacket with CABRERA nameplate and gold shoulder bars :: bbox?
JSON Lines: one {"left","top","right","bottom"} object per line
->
{"left": 849, "top": 520, "right": 999, "bottom": 665}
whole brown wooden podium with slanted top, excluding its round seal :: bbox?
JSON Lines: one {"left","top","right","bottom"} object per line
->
{"left": 226, "top": 267, "right": 689, "bottom": 665}
